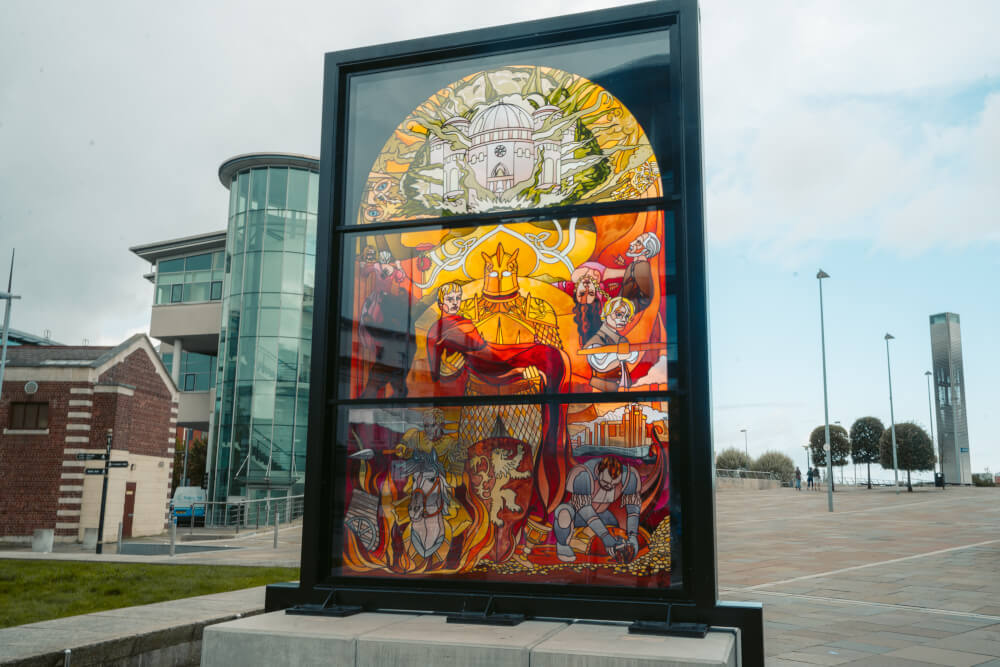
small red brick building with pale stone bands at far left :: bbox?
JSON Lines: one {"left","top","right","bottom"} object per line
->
{"left": 0, "top": 334, "right": 178, "bottom": 542}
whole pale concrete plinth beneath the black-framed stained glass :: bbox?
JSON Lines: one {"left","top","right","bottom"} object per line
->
{"left": 201, "top": 612, "right": 737, "bottom": 667}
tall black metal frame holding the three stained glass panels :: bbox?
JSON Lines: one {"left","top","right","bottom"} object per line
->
{"left": 266, "top": 0, "right": 763, "bottom": 665}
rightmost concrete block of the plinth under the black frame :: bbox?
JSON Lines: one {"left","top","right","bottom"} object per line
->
{"left": 531, "top": 621, "right": 737, "bottom": 667}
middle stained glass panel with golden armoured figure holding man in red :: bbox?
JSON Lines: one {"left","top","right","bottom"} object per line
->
{"left": 340, "top": 211, "right": 676, "bottom": 400}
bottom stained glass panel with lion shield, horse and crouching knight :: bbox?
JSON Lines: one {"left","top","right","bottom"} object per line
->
{"left": 340, "top": 401, "right": 671, "bottom": 587}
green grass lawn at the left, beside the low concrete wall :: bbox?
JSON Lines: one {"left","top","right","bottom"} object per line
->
{"left": 0, "top": 560, "right": 299, "bottom": 628}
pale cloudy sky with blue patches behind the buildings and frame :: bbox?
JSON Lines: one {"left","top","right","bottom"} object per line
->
{"left": 0, "top": 0, "right": 1000, "bottom": 480}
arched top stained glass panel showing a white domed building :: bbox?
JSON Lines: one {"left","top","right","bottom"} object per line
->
{"left": 356, "top": 66, "right": 662, "bottom": 224}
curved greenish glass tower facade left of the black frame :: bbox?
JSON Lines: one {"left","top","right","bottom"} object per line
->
{"left": 211, "top": 156, "right": 319, "bottom": 500}
